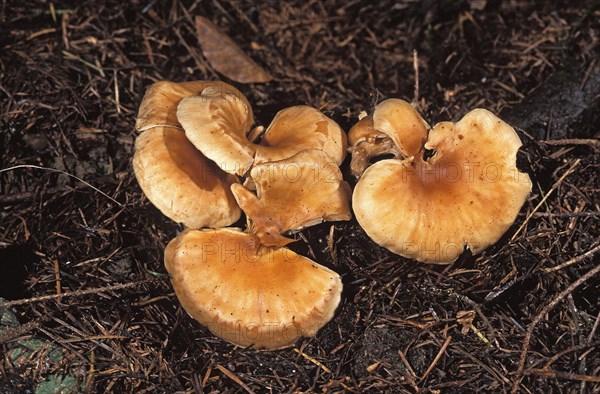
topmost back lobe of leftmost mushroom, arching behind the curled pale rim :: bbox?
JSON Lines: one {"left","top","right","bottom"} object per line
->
{"left": 135, "top": 81, "right": 252, "bottom": 131}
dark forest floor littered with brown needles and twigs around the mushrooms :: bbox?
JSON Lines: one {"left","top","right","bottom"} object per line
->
{"left": 0, "top": 0, "right": 600, "bottom": 393}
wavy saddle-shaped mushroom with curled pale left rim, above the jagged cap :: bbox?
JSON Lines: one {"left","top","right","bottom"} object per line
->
{"left": 177, "top": 101, "right": 347, "bottom": 176}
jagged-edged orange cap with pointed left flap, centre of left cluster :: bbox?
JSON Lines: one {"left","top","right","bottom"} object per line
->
{"left": 231, "top": 149, "right": 352, "bottom": 246}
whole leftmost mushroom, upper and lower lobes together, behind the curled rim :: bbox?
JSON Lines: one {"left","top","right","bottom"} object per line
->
{"left": 133, "top": 81, "right": 244, "bottom": 228}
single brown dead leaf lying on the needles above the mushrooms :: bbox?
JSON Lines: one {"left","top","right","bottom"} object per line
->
{"left": 196, "top": 16, "right": 273, "bottom": 83}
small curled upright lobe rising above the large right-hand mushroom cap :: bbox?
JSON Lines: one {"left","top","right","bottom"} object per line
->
{"left": 373, "top": 99, "right": 429, "bottom": 157}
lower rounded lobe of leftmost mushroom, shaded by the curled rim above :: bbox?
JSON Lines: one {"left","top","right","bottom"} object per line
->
{"left": 133, "top": 127, "right": 241, "bottom": 228}
